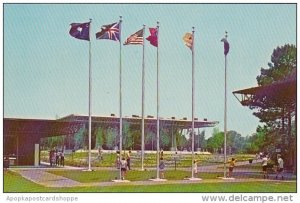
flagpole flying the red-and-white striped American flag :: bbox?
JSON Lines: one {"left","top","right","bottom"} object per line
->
{"left": 141, "top": 25, "right": 145, "bottom": 171}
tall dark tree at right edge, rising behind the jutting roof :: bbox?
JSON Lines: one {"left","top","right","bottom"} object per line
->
{"left": 250, "top": 44, "right": 297, "bottom": 163}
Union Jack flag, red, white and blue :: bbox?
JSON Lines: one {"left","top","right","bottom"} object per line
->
{"left": 96, "top": 23, "right": 120, "bottom": 41}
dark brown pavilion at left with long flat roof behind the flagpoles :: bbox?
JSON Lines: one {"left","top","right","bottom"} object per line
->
{"left": 3, "top": 114, "right": 218, "bottom": 166}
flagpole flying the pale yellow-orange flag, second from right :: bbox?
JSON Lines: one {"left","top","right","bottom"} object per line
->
{"left": 192, "top": 27, "right": 195, "bottom": 178}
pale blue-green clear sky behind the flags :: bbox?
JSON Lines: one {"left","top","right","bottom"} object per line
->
{"left": 3, "top": 3, "right": 296, "bottom": 136}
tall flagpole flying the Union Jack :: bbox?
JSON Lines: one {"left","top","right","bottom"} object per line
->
{"left": 119, "top": 16, "right": 123, "bottom": 180}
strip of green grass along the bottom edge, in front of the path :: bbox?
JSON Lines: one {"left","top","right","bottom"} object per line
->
{"left": 4, "top": 171, "right": 296, "bottom": 193}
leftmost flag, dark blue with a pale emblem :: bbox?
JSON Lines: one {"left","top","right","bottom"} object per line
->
{"left": 69, "top": 22, "right": 90, "bottom": 41}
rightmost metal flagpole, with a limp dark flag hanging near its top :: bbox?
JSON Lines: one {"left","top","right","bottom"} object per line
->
{"left": 224, "top": 31, "right": 228, "bottom": 178}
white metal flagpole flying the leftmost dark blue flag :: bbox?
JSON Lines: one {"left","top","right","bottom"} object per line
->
{"left": 88, "top": 19, "right": 92, "bottom": 171}
